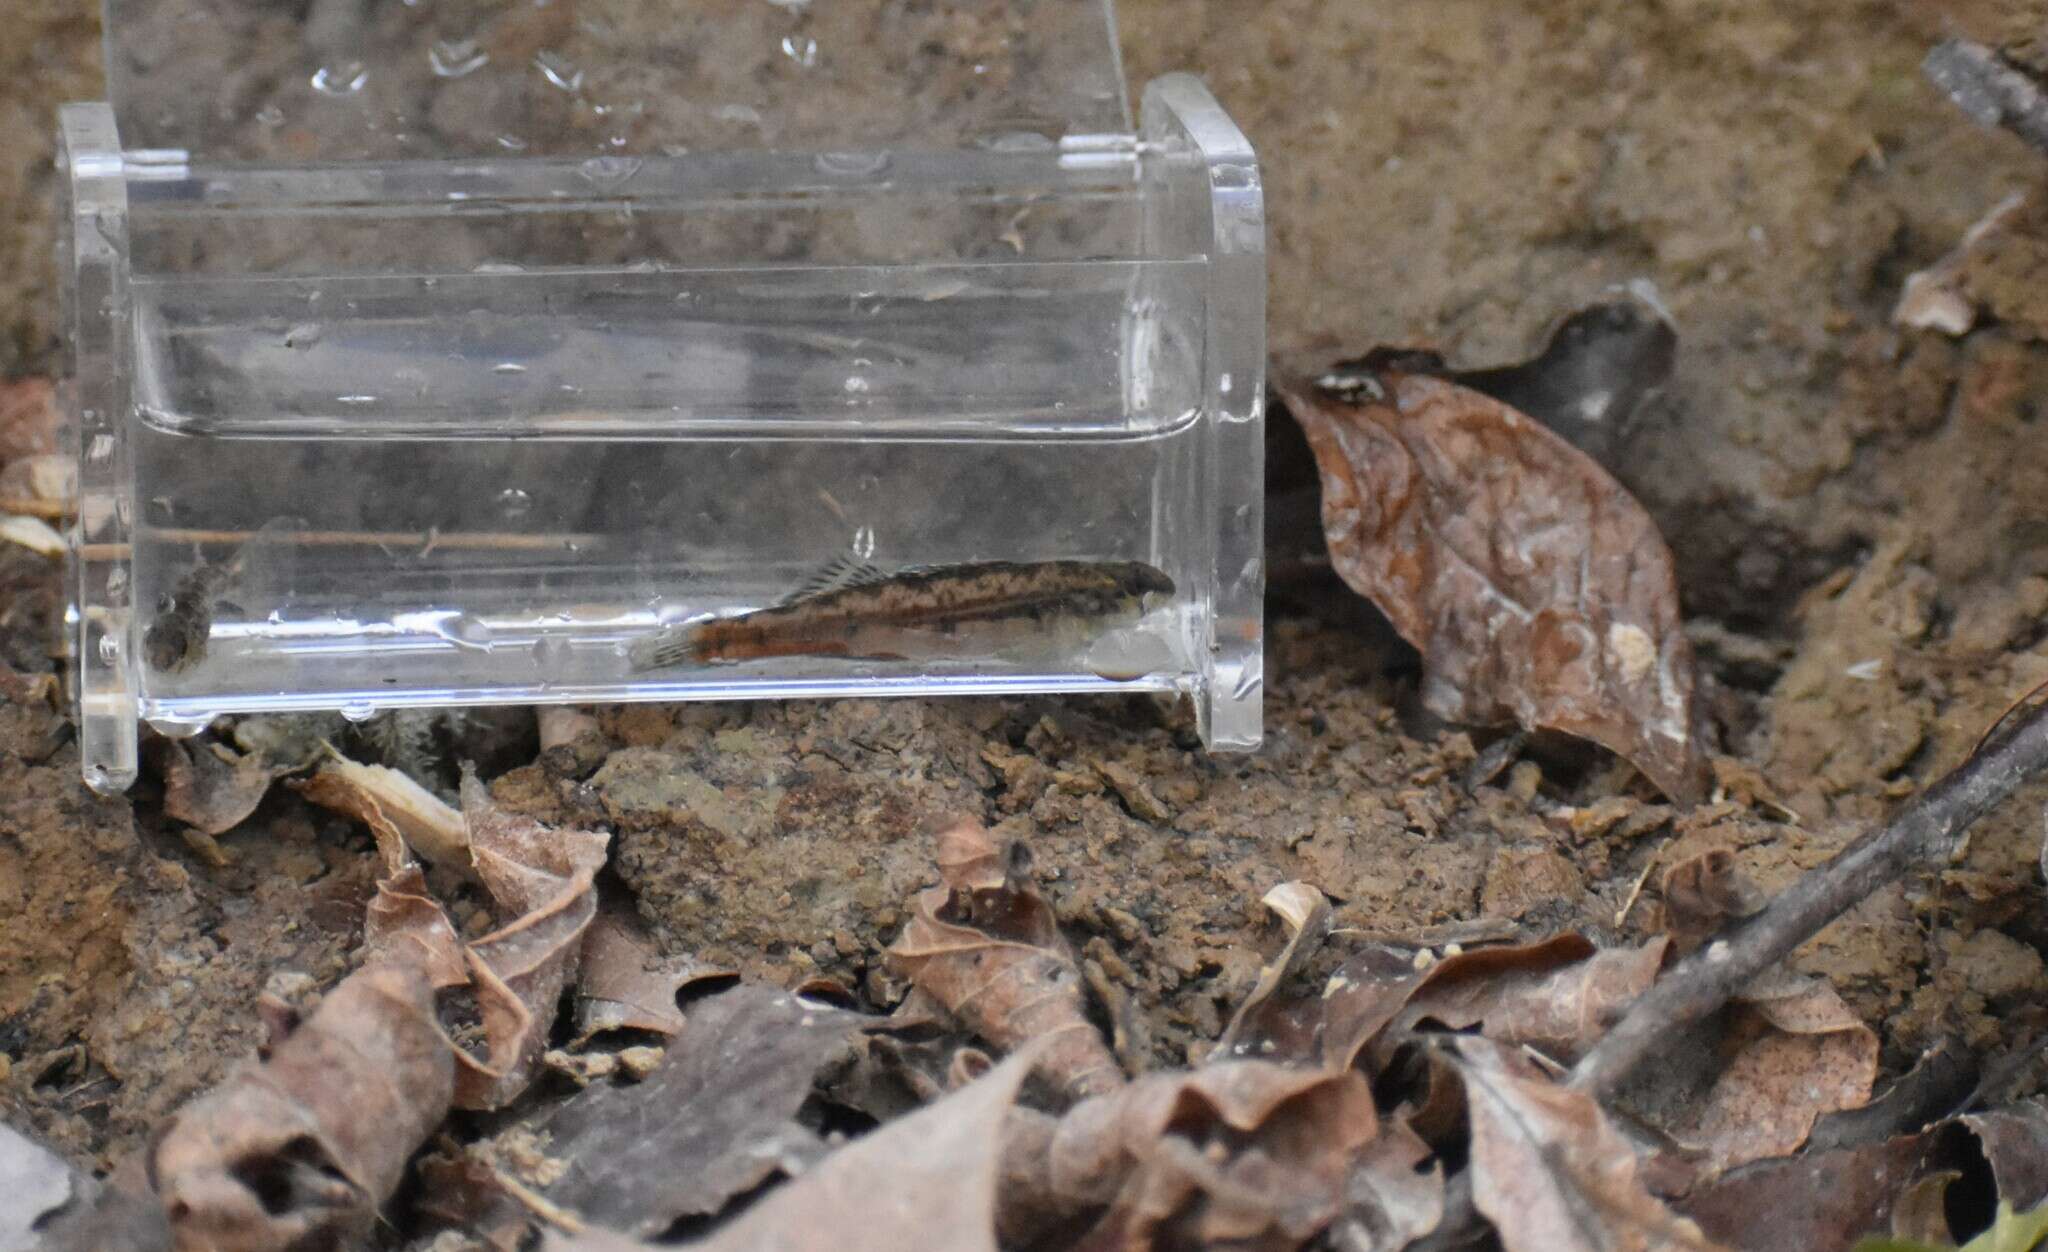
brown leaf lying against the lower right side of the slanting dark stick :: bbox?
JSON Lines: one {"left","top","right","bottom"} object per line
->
{"left": 1626, "top": 975, "right": 1878, "bottom": 1174}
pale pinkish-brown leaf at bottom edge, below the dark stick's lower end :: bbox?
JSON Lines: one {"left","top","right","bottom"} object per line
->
{"left": 1452, "top": 1037, "right": 1714, "bottom": 1252}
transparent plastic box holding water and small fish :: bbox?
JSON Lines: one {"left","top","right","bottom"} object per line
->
{"left": 59, "top": 0, "right": 1266, "bottom": 789}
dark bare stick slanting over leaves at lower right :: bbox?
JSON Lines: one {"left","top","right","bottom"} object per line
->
{"left": 1571, "top": 705, "right": 2048, "bottom": 1096}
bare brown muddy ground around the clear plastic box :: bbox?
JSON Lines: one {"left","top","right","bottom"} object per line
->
{"left": 0, "top": 0, "right": 2048, "bottom": 1196}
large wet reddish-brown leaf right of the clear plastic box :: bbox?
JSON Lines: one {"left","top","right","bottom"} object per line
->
{"left": 1280, "top": 369, "right": 1708, "bottom": 801}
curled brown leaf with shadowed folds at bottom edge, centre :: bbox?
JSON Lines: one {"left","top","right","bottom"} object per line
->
{"left": 997, "top": 1059, "right": 1378, "bottom": 1248}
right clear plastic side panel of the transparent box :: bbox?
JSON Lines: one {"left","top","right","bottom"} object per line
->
{"left": 1139, "top": 74, "right": 1266, "bottom": 750}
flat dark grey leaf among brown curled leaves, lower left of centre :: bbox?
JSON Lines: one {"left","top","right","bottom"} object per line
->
{"left": 545, "top": 986, "right": 864, "bottom": 1236}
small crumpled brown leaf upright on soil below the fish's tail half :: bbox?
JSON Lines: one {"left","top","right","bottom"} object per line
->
{"left": 889, "top": 820, "right": 1124, "bottom": 1098}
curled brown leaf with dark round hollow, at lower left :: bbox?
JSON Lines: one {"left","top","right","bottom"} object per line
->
{"left": 150, "top": 965, "right": 455, "bottom": 1252}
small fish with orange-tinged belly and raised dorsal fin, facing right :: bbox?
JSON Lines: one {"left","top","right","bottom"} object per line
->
{"left": 631, "top": 561, "right": 1174, "bottom": 670}
